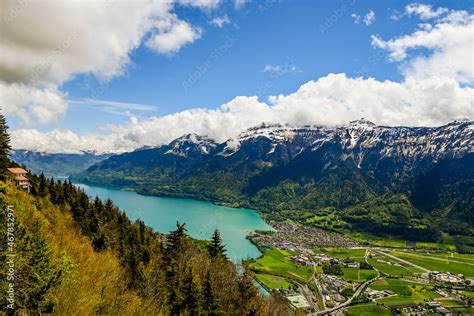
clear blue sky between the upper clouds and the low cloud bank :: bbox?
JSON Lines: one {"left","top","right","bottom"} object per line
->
{"left": 1, "top": 0, "right": 472, "bottom": 153}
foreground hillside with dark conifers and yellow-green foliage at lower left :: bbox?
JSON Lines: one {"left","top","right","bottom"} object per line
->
{"left": 0, "top": 115, "right": 289, "bottom": 315}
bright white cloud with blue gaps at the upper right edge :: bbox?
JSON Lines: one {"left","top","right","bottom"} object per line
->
{"left": 372, "top": 11, "right": 474, "bottom": 84}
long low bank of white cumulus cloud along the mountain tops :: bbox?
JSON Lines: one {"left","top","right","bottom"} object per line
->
{"left": 12, "top": 74, "right": 474, "bottom": 152}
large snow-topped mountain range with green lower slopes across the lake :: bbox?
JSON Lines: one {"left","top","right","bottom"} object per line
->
{"left": 74, "top": 120, "right": 474, "bottom": 239}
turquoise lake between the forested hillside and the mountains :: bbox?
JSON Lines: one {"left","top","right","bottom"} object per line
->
{"left": 76, "top": 184, "right": 272, "bottom": 261}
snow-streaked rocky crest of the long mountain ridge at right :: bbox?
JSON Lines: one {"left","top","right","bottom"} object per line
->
{"left": 220, "top": 120, "right": 474, "bottom": 170}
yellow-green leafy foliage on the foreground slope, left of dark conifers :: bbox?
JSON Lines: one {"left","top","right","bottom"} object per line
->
{"left": 0, "top": 181, "right": 159, "bottom": 315}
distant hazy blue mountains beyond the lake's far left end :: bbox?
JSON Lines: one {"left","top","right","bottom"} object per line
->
{"left": 10, "top": 150, "right": 111, "bottom": 177}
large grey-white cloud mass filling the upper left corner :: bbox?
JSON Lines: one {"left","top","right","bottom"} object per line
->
{"left": 0, "top": 0, "right": 202, "bottom": 123}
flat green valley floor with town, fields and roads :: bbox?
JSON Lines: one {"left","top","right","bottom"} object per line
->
{"left": 249, "top": 222, "right": 474, "bottom": 315}
